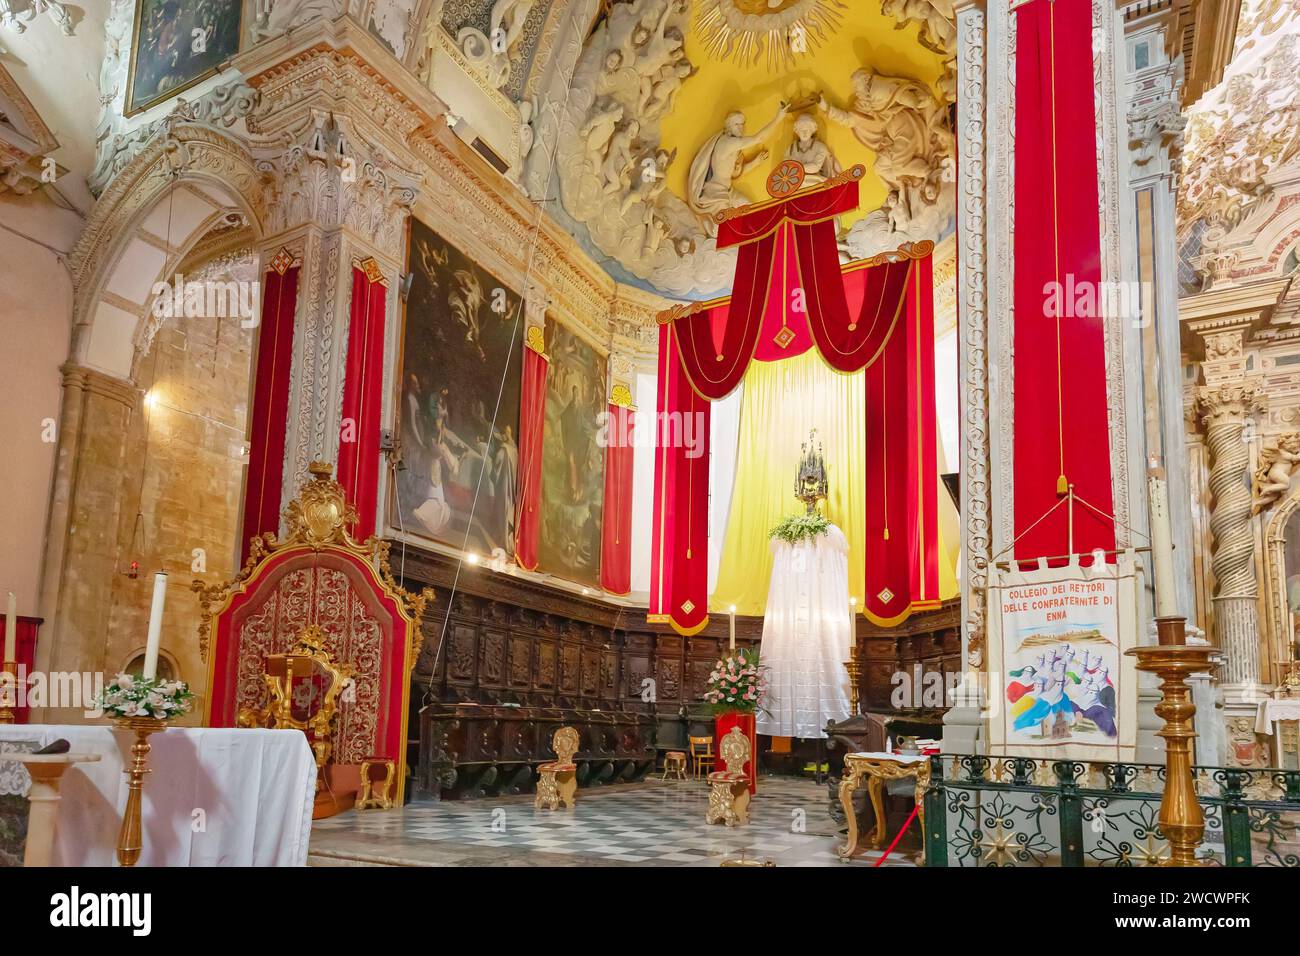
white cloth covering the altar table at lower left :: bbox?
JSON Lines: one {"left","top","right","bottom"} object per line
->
{"left": 0, "top": 724, "right": 316, "bottom": 866}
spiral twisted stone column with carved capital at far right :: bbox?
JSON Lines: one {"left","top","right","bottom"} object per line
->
{"left": 1197, "top": 380, "right": 1264, "bottom": 684}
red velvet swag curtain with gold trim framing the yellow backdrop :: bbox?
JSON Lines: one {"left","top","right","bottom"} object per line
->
{"left": 650, "top": 170, "right": 939, "bottom": 635}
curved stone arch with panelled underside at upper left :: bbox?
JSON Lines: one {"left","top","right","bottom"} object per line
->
{"left": 70, "top": 121, "right": 267, "bottom": 380}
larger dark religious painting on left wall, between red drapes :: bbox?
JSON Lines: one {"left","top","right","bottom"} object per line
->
{"left": 395, "top": 221, "right": 523, "bottom": 559}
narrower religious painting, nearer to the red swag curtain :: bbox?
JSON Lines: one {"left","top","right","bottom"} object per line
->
{"left": 537, "top": 316, "right": 606, "bottom": 587}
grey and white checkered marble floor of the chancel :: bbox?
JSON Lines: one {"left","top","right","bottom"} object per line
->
{"left": 309, "top": 777, "right": 913, "bottom": 866}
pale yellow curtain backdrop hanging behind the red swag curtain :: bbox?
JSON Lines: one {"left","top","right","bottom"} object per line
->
{"left": 709, "top": 349, "right": 957, "bottom": 617}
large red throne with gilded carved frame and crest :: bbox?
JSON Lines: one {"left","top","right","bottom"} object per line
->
{"left": 192, "top": 462, "right": 433, "bottom": 817}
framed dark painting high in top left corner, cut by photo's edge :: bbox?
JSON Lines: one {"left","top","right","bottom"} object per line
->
{"left": 126, "top": 0, "right": 242, "bottom": 114}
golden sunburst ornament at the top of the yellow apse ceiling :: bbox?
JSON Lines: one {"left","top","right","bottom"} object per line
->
{"left": 696, "top": 0, "right": 846, "bottom": 69}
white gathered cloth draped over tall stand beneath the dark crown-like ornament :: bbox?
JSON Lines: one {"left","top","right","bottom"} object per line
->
{"left": 755, "top": 524, "right": 850, "bottom": 737}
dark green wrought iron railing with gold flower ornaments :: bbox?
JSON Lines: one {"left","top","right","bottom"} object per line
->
{"left": 924, "top": 754, "right": 1300, "bottom": 866}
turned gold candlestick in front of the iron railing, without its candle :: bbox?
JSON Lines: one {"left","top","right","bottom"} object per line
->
{"left": 1125, "top": 617, "right": 1218, "bottom": 866}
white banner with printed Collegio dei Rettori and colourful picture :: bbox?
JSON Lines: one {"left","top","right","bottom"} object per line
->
{"left": 987, "top": 550, "right": 1143, "bottom": 762}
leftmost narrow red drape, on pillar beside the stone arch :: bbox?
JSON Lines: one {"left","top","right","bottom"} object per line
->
{"left": 239, "top": 260, "right": 300, "bottom": 564}
